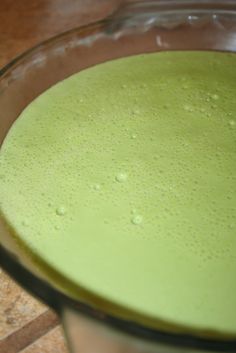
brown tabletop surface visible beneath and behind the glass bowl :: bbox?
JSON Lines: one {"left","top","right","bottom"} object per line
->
{"left": 0, "top": 0, "right": 121, "bottom": 353}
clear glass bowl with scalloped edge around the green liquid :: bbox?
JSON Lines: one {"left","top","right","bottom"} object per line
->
{"left": 0, "top": 0, "right": 236, "bottom": 353}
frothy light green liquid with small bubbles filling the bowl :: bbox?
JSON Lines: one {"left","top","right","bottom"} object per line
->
{"left": 0, "top": 52, "right": 236, "bottom": 335}
